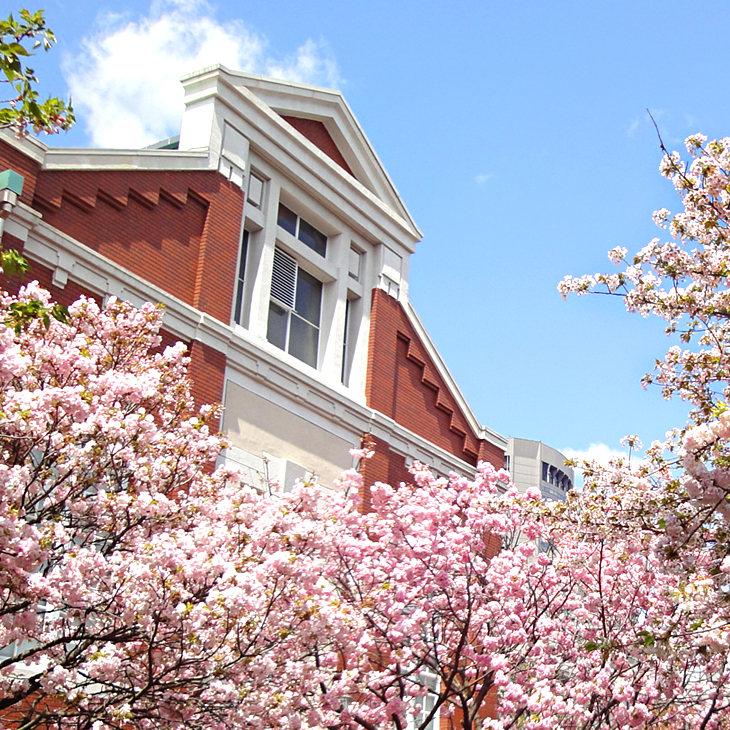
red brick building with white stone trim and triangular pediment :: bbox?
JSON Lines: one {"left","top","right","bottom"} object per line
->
{"left": 0, "top": 66, "right": 508, "bottom": 498}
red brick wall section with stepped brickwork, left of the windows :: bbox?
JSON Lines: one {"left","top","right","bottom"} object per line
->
{"left": 32, "top": 170, "right": 243, "bottom": 323}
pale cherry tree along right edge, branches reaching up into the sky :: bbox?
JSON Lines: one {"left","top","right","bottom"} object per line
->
{"left": 560, "top": 135, "right": 730, "bottom": 727}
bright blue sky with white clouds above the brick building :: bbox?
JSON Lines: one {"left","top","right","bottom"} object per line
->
{"left": 18, "top": 0, "right": 730, "bottom": 464}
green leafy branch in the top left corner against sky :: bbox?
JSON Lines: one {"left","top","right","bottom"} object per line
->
{"left": 0, "top": 8, "right": 74, "bottom": 137}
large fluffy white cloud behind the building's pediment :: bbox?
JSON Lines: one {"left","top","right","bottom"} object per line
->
{"left": 64, "top": 0, "right": 341, "bottom": 147}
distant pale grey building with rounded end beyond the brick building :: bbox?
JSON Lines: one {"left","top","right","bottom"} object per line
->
{"left": 505, "top": 438, "right": 574, "bottom": 501}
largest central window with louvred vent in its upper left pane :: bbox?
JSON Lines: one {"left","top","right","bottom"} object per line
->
{"left": 266, "top": 248, "right": 322, "bottom": 368}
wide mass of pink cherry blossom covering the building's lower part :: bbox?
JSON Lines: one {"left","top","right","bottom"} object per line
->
{"left": 0, "top": 274, "right": 730, "bottom": 730}
